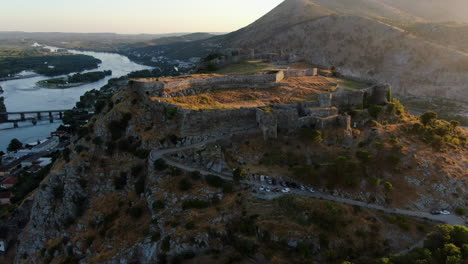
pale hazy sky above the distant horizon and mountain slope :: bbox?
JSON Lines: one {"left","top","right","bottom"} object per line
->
{"left": 0, "top": 0, "right": 283, "bottom": 33}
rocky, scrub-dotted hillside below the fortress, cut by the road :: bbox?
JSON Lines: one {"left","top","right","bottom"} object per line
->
{"left": 11, "top": 85, "right": 466, "bottom": 264}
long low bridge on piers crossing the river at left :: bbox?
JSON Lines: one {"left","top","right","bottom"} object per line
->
{"left": 0, "top": 109, "right": 70, "bottom": 128}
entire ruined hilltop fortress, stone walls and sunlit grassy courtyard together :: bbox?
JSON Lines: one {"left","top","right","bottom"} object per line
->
{"left": 130, "top": 69, "right": 391, "bottom": 141}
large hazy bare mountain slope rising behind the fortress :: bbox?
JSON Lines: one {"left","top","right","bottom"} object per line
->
{"left": 226, "top": 0, "right": 468, "bottom": 101}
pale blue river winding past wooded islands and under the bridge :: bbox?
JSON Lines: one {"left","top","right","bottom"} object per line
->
{"left": 0, "top": 47, "right": 151, "bottom": 151}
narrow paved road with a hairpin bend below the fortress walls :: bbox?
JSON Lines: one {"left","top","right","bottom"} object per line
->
{"left": 149, "top": 140, "right": 465, "bottom": 225}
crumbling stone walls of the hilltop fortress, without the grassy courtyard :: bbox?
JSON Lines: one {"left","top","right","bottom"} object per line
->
{"left": 131, "top": 69, "right": 391, "bottom": 140}
